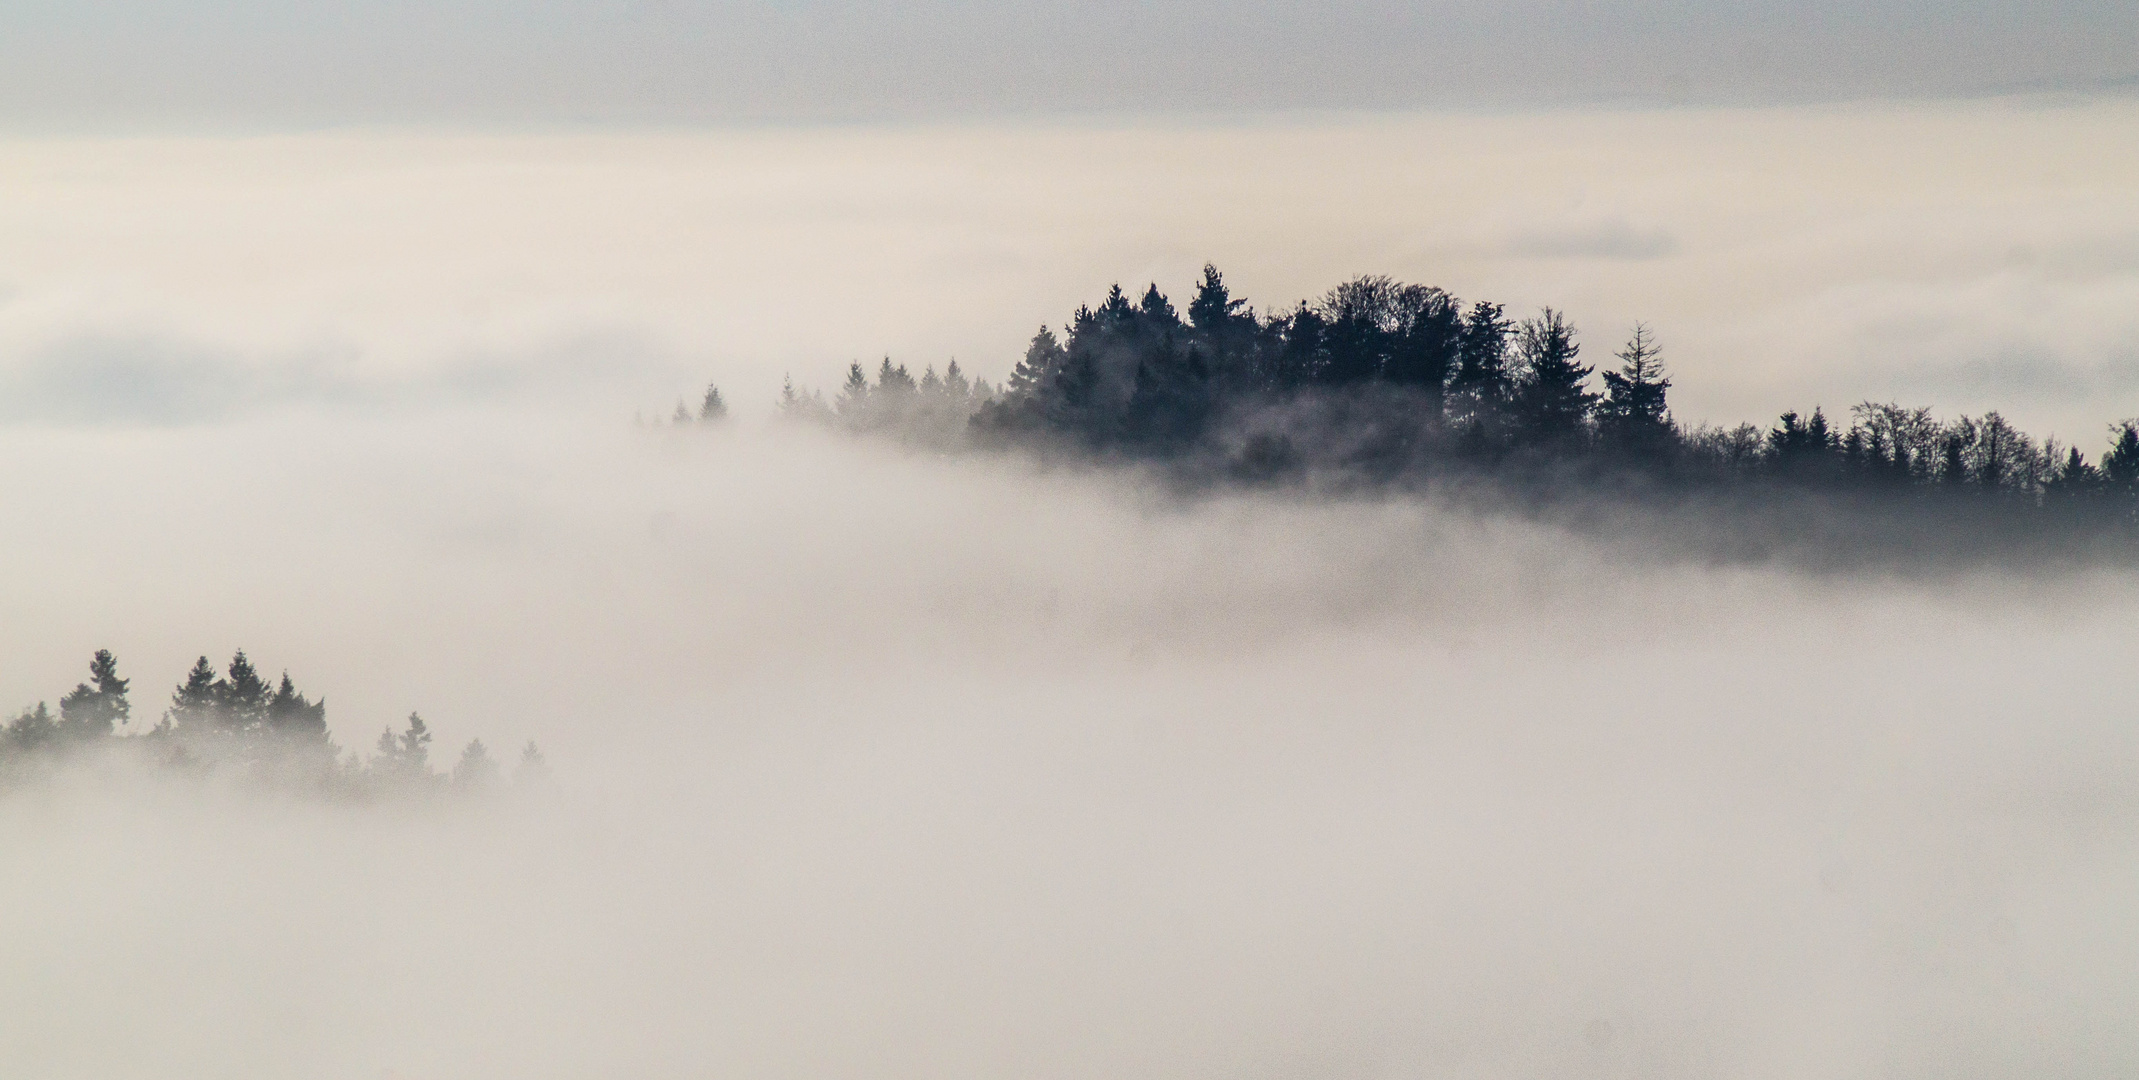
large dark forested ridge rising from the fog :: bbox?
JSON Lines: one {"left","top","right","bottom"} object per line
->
{"left": 731, "top": 265, "right": 2139, "bottom": 558}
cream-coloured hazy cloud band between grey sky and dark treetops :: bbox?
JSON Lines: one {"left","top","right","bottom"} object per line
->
{"left": 0, "top": 98, "right": 2139, "bottom": 440}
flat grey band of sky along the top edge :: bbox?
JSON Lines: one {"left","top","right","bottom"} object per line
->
{"left": 0, "top": 0, "right": 2139, "bottom": 130}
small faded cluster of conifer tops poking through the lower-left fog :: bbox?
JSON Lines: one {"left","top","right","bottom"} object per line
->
{"left": 0, "top": 650, "right": 550, "bottom": 796}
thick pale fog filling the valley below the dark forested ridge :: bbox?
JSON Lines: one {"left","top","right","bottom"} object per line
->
{"left": 0, "top": 406, "right": 2139, "bottom": 1080}
